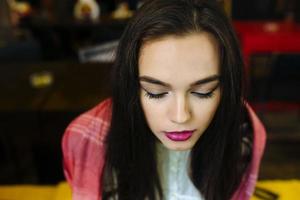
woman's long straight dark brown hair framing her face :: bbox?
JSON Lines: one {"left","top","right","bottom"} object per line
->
{"left": 103, "top": 0, "right": 244, "bottom": 200}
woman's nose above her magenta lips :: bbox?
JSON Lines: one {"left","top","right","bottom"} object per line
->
{"left": 170, "top": 97, "right": 191, "bottom": 124}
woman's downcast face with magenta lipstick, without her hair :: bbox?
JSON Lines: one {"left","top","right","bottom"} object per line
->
{"left": 139, "top": 32, "right": 221, "bottom": 150}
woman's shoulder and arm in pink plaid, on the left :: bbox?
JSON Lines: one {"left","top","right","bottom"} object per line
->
{"left": 62, "top": 99, "right": 112, "bottom": 200}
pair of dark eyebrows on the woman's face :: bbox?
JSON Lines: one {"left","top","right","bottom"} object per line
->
{"left": 139, "top": 75, "right": 220, "bottom": 88}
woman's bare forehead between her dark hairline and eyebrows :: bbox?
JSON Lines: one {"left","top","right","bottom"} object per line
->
{"left": 139, "top": 32, "right": 220, "bottom": 85}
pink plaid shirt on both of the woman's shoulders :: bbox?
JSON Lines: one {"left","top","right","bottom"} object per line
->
{"left": 62, "top": 99, "right": 266, "bottom": 200}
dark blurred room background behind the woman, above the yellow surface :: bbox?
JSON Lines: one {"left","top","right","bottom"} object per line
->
{"left": 0, "top": 0, "right": 300, "bottom": 199}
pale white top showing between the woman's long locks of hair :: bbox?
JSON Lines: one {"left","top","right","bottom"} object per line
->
{"left": 157, "top": 142, "right": 204, "bottom": 200}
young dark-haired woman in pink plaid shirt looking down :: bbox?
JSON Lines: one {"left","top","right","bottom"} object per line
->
{"left": 62, "top": 0, "right": 265, "bottom": 200}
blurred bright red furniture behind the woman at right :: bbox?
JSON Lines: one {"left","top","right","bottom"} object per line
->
{"left": 233, "top": 21, "right": 300, "bottom": 110}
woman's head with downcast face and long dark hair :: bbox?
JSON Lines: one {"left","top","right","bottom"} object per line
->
{"left": 107, "top": 0, "right": 243, "bottom": 199}
